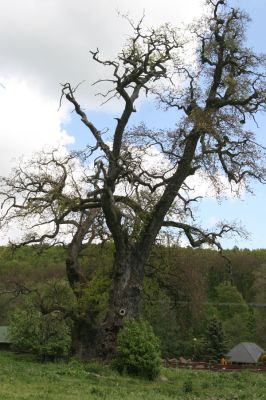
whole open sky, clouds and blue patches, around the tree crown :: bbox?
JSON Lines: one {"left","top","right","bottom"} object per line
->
{"left": 0, "top": 0, "right": 266, "bottom": 248}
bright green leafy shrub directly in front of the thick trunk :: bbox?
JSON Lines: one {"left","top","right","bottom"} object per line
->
{"left": 115, "top": 320, "right": 161, "bottom": 380}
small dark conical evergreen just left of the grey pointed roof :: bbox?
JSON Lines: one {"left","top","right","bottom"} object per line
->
{"left": 205, "top": 316, "right": 226, "bottom": 362}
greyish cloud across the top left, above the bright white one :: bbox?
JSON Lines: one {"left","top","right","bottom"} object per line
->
{"left": 0, "top": 0, "right": 202, "bottom": 105}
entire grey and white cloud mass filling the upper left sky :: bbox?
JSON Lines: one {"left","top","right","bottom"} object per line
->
{"left": 0, "top": 0, "right": 205, "bottom": 175}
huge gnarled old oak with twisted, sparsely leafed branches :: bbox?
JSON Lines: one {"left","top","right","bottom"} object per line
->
{"left": 1, "top": 0, "right": 266, "bottom": 357}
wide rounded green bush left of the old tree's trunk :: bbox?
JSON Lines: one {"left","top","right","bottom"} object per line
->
{"left": 10, "top": 281, "right": 75, "bottom": 360}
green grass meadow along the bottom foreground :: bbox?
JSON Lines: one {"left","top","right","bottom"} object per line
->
{"left": 0, "top": 353, "right": 266, "bottom": 400}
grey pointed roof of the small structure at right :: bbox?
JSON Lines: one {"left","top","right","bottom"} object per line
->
{"left": 227, "top": 342, "right": 264, "bottom": 364}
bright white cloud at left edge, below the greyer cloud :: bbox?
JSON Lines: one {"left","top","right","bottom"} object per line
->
{"left": 0, "top": 78, "right": 74, "bottom": 175}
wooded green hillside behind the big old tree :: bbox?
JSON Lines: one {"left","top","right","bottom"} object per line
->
{"left": 0, "top": 243, "right": 266, "bottom": 359}
